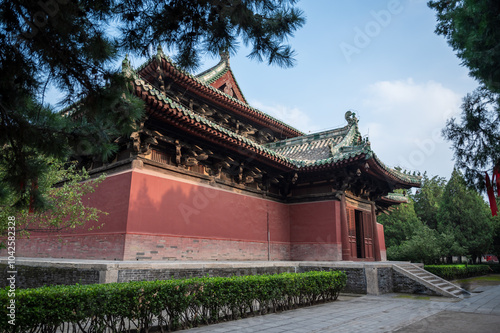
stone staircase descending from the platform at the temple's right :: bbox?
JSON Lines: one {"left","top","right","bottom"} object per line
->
{"left": 393, "top": 263, "right": 470, "bottom": 298}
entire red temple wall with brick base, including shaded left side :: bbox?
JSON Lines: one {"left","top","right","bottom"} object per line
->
{"left": 9, "top": 169, "right": 385, "bottom": 260}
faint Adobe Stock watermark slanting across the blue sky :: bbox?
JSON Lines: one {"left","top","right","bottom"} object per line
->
{"left": 339, "top": 0, "right": 404, "bottom": 63}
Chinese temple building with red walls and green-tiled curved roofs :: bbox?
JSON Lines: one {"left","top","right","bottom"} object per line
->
{"left": 19, "top": 49, "right": 420, "bottom": 261}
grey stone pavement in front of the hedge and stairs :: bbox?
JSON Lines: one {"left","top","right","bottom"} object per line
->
{"left": 181, "top": 286, "right": 500, "bottom": 333}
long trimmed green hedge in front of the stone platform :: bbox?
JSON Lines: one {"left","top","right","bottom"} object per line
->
{"left": 0, "top": 271, "right": 347, "bottom": 332}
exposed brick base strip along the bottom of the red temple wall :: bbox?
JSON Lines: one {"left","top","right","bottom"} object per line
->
{"left": 9, "top": 234, "right": 348, "bottom": 261}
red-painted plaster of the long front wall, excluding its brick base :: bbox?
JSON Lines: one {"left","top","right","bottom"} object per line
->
{"left": 127, "top": 172, "right": 290, "bottom": 242}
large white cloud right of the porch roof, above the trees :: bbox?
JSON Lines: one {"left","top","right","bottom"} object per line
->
{"left": 360, "top": 78, "right": 462, "bottom": 177}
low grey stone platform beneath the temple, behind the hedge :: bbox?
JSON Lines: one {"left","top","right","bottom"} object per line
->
{"left": 0, "top": 258, "right": 448, "bottom": 295}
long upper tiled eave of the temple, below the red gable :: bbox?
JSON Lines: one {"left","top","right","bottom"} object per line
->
{"left": 137, "top": 55, "right": 304, "bottom": 137}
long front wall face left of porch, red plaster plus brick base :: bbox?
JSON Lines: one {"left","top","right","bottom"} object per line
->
{"left": 124, "top": 171, "right": 290, "bottom": 260}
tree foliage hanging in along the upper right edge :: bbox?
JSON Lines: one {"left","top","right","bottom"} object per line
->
{"left": 428, "top": 0, "right": 500, "bottom": 190}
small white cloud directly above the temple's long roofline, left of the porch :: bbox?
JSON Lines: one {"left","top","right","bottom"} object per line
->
{"left": 250, "top": 101, "right": 315, "bottom": 132}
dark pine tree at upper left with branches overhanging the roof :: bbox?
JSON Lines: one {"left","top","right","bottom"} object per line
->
{"left": 0, "top": 0, "right": 305, "bottom": 209}
